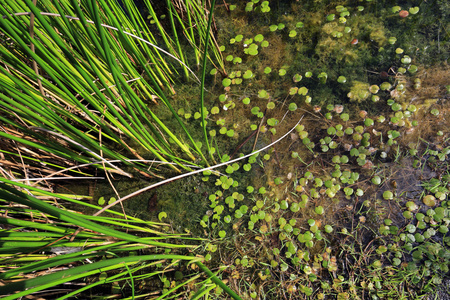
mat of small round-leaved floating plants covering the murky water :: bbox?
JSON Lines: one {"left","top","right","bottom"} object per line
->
{"left": 4, "top": 0, "right": 449, "bottom": 299}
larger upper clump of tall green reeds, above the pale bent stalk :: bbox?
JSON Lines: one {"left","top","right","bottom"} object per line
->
{"left": 0, "top": 0, "right": 220, "bottom": 175}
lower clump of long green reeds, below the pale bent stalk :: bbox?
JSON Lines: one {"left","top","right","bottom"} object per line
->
{"left": 0, "top": 178, "right": 243, "bottom": 299}
